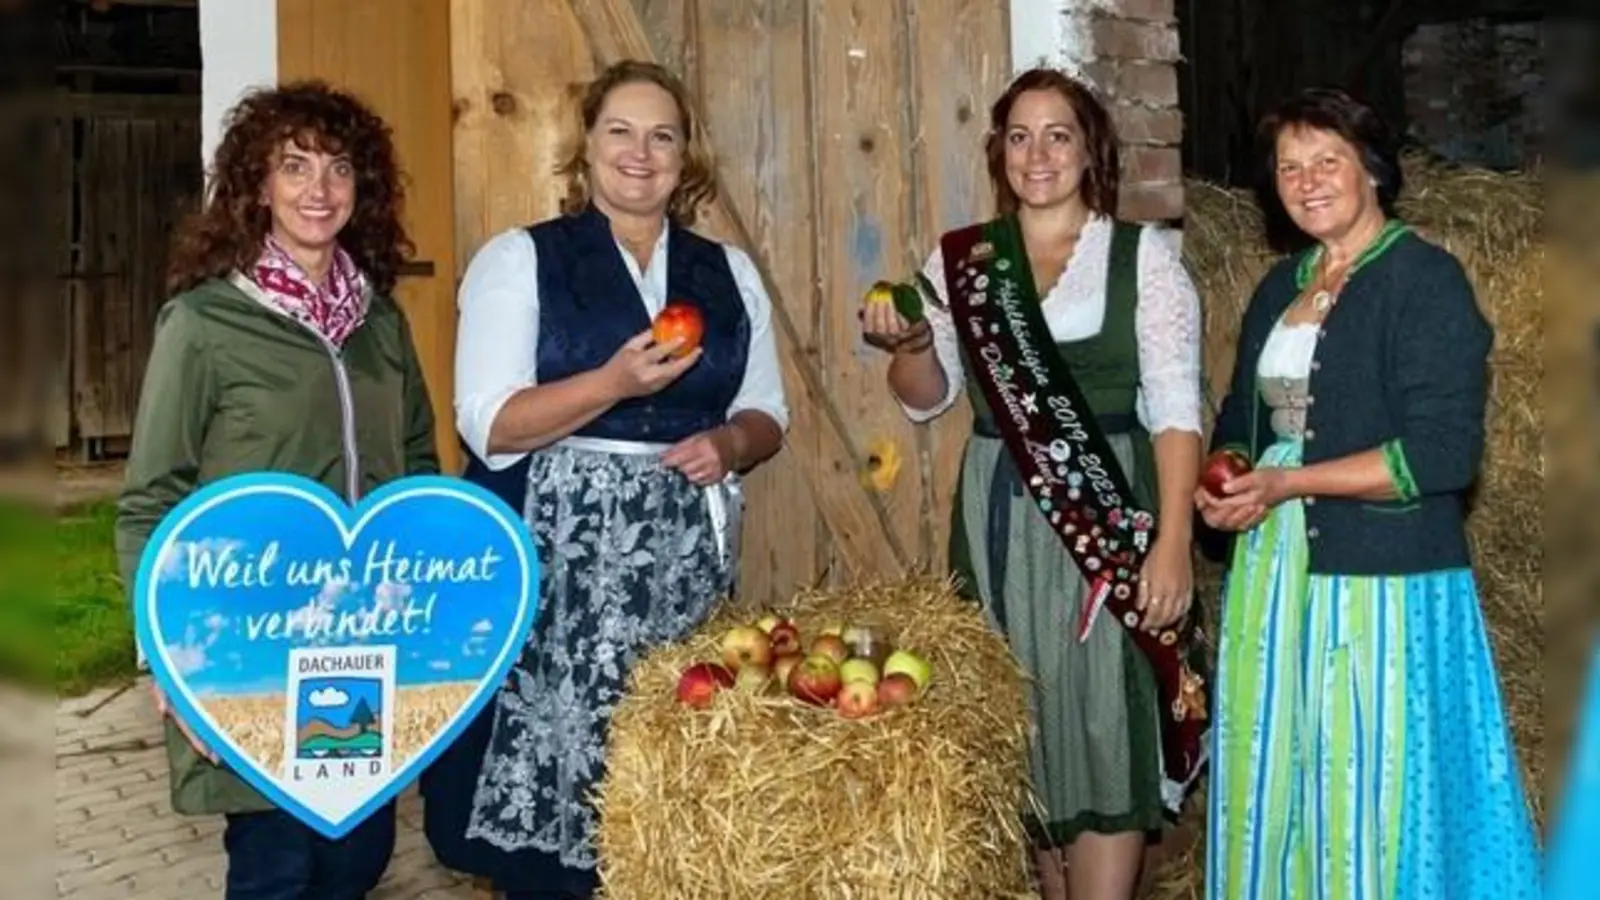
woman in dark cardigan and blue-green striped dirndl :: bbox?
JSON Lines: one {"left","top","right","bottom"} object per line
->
{"left": 1195, "top": 90, "right": 1539, "bottom": 900}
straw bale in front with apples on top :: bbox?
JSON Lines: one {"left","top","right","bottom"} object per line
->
{"left": 597, "top": 580, "right": 1030, "bottom": 900}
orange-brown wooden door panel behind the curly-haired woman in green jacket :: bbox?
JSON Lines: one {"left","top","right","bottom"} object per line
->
{"left": 278, "top": 0, "right": 461, "bottom": 471}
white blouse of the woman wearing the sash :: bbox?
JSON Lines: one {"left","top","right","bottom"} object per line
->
{"left": 901, "top": 216, "right": 1202, "bottom": 434}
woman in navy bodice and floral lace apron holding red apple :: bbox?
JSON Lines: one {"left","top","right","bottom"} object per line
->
{"left": 424, "top": 62, "right": 787, "bottom": 900}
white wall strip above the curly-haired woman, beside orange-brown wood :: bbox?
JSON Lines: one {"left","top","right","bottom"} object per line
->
{"left": 200, "top": 0, "right": 278, "bottom": 173}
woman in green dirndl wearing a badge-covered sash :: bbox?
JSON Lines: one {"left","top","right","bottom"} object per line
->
{"left": 862, "top": 69, "right": 1202, "bottom": 900}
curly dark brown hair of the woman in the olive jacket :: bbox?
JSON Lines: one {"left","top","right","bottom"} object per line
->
{"left": 166, "top": 80, "right": 416, "bottom": 293}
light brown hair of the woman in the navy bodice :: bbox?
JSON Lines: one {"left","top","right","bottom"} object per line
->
{"left": 555, "top": 59, "right": 717, "bottom": 226}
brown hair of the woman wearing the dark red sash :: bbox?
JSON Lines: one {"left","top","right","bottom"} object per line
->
{"left": 984, "top": 69, "right": 1120, "bottom": 216}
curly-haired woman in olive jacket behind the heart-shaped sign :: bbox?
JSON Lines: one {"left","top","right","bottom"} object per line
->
{"left": 117, "top": 82, "right": 438, "bottom": 900}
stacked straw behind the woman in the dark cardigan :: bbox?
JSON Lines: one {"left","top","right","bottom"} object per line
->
{"left": 1152, "top": 157, "right": 1546, "bottom": 898}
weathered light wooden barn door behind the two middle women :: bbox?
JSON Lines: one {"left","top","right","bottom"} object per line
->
{"left": 451, "top": 0, "right": 1010, "bottom": 602}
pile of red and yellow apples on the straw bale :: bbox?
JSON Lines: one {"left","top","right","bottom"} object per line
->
{"left": 677, "top": 615, "right": 933, "bottom": 719}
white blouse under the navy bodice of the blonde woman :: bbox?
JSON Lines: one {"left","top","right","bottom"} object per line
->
{"left": 454, "top": 227, "right": 789, "bottom": 469}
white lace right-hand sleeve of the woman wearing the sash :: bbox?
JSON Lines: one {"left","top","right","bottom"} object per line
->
{"left": 1134, "top": 227, "right": 1202, "bottom": 434}
